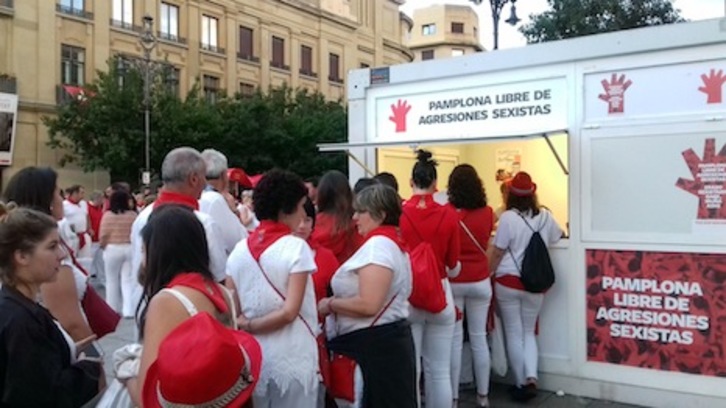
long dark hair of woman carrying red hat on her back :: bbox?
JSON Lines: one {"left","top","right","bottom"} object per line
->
{"left": 137, "top": 204, "right": 214, "bottom": 338}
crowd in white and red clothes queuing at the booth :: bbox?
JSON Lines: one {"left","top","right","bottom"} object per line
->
{"left": 0, "top": 147, "right": 563, "bottom": 408}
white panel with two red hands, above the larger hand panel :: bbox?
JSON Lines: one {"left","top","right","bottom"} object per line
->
{"left": 585, "top": 60, "right": 726, "bottom": 122}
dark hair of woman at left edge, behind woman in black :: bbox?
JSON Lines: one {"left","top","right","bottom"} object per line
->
{"left": 3, "top": 167, "right": 58, "bottom": 215}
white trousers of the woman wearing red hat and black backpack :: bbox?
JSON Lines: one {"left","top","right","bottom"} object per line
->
{"left": 495, "top": 283, "right": 544, "bottom": 385}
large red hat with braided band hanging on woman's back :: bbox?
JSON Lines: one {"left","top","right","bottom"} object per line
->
{"left": 142, "top": 312, "right": 262, "bottom": 408}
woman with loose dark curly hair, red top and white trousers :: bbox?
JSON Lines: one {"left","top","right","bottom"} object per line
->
{"left": 448, "top": 164, "right": 496, "bottom": 407}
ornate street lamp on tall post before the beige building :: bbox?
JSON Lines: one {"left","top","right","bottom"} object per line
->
{"left": 117, "top": 14, "right": 167, "bottom": 185}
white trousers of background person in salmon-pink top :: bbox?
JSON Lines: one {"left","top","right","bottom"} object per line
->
{"left": 103, "top": 244, "right": 136, "bottom": 317}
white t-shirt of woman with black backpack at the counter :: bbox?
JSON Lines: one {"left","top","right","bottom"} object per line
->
{"left": 494, "top": 208, "right": 562, "bottom": 276}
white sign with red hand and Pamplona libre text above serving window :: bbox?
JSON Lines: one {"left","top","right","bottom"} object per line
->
{"left": 374, "top": 79, "right": 567, "bottom": 142}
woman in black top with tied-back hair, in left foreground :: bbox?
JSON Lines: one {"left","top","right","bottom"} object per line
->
{"left": 0, "top": 208, "right": 105, "bottom": 407}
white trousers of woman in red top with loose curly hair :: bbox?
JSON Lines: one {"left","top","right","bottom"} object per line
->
{"left": 451, "top": 278, "right": 492, "bottom": 399}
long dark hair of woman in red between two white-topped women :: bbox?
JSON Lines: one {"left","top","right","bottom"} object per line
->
{"left": 318, "top": 170, "right": 353, "bottom": 232}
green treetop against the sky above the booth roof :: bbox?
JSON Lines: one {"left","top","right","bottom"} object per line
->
{"left": 519, "top": 0, "right": 685, "bottom": 43}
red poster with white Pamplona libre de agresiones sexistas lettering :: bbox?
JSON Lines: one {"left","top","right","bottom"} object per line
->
{"left": 586, "top": 249, "right": 726, "bottom": 377}
